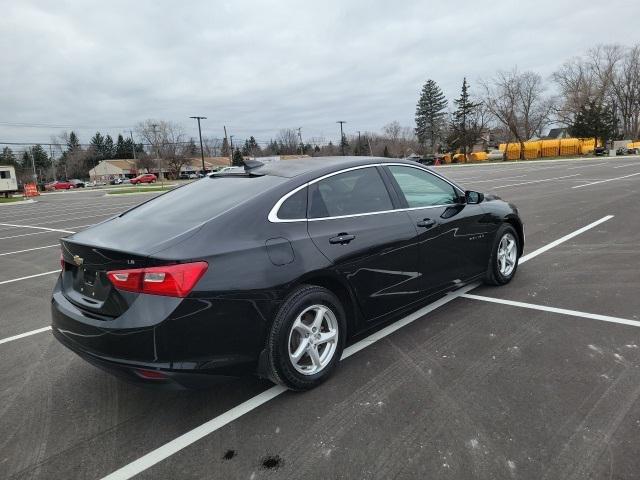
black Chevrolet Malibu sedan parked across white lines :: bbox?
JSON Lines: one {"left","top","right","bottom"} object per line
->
{"left": 52, "top": 157, "right": 524, "bottom": 390}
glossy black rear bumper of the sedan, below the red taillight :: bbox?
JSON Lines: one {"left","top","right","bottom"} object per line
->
{"left": 51, "top": 280, "right": 264, "bottom": 387}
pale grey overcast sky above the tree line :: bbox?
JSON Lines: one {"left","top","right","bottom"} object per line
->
{"left": 0, "top": 0, "right": 640, "bottom": 148}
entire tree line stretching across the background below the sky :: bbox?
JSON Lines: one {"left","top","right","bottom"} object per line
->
{"left": 0, "top": 40, "right": 640, "bottom": 179}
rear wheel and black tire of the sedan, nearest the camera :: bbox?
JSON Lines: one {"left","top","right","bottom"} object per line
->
{"left": 266, "top": 285, "right": 346, "bottom": 390}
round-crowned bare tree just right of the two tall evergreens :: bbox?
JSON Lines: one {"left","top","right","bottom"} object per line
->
{"left": 482, "top": 69, "right": 552, "bottom": 158}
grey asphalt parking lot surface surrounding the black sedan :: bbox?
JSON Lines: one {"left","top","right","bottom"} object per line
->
{"left": 0, "top": 157, "right": 640, "bottom": 479}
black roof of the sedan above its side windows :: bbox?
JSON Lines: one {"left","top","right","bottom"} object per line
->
{"left": 251, "top": 156, "right": 416, "bottom": 178}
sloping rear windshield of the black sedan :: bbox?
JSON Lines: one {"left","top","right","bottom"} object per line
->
{"left": 124, "top": 175, "right": 286, "bottom": 228}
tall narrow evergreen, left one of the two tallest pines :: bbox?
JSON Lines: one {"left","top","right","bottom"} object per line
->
{"left": 416, "top": 79, "right": 447, "bottom": 153}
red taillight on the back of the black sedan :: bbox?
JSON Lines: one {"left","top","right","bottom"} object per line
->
{"left": 107, "top": 262, "right": 209, "bottom": 298}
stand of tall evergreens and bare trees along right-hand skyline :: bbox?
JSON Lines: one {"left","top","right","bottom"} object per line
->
{"left": 415, "top": 44, "right": 640, "bottom": 159}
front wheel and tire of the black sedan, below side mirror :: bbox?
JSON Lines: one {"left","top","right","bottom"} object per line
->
{"left": 484, "top": 223, "right": 520, "bottom": 285}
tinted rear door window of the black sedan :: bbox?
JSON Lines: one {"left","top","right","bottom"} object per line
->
{"left": 309, "top": 167, "right": 393, "bottom": 218}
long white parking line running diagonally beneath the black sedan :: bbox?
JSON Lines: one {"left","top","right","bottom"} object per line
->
{"left": 96, "top": 215, "right": 613, "bottom": 480}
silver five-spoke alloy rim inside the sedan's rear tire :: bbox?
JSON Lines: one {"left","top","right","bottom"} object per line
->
{"left": 288, "top": 305, "right": 338, "bottom": 375}
